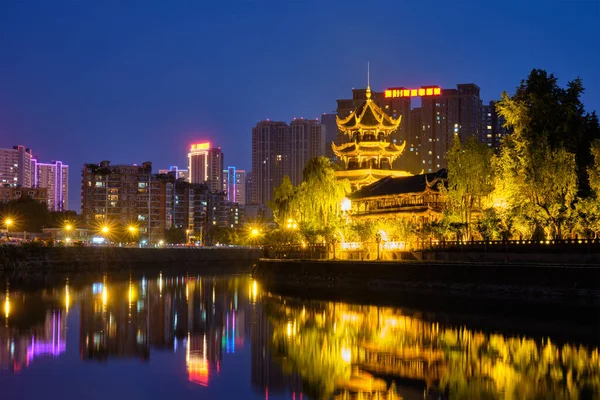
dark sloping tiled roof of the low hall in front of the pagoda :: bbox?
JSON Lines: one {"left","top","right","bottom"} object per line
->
{"left": 348, "top": 169, "right": 448, "bottom": 200}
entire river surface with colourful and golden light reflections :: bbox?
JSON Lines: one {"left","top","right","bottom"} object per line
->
{"left": 0, "top": 273, "right": 600, "bottom": 400}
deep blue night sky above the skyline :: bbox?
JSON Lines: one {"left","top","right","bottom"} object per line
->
{"left": 0, "top": 0, "right": 600, "bottom": 212}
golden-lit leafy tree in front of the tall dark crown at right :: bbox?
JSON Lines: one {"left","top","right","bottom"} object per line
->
{"left": 493, "top": 81, "right": 578, "bottom": 238}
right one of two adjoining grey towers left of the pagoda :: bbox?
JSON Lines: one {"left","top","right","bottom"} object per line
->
{"left": 284, "top": 118, "right": 331, "bottom": 186}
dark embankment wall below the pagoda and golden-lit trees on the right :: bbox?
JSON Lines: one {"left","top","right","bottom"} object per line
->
{"left": 253, "top": 259, "right": 600, "bottom": 306}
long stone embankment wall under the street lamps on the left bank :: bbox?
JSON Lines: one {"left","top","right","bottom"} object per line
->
{"left": 0, "top": 246, "right": 262, "bottom": 273}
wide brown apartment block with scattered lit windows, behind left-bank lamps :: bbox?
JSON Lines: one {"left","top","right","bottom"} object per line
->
{"left": 81, "top": 161, "right": 173, "bottom": 243}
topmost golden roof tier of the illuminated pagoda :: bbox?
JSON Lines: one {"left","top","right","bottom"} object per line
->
{"left": 336, "top": 87, "right": 401, "bottom": 134}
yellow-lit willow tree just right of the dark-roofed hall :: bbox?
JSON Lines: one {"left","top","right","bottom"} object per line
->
{"left": 445, "top": 136, "right": 493, "bottom": 239}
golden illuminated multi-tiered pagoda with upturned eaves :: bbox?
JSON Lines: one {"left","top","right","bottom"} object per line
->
{"left": 331, "top": 86, "right": 412, "bottom": 190}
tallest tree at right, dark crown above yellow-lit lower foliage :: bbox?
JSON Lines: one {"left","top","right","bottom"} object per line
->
{"left": 493, "top": 70, "right": 584, "bottom": 238}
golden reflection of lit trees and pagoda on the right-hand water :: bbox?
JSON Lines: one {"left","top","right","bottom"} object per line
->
{"left": 264, "top": 296, "right": 600, "bottom": 399}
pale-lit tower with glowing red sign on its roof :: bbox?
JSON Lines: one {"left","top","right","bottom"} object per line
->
{"left": 188, "top": 142, "right": 223, "bottom": 192}
